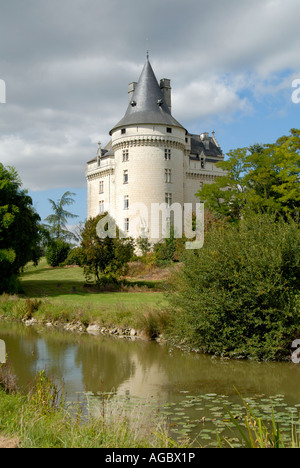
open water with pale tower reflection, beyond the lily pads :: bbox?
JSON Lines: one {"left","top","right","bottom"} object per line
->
{"left": 0, "top": 323, "right": 300, "bottom": 404}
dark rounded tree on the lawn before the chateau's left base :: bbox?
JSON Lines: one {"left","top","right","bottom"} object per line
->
{"left": 76, "top": 213, "right": 134, "bottom": 284}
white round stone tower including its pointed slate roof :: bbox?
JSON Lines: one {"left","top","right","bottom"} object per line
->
{"left": 110, "top": 57, "right": 187, "bottom": 242}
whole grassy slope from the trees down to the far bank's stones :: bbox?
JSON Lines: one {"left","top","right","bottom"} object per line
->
{"left": 0, "top": 259, "right": 169, "bottom": 338}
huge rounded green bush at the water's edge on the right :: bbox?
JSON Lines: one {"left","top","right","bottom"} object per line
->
{"left": 170, "top": 215, "right": 300, "bottom": 360}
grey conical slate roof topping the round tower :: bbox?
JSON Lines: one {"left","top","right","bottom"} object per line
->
{"left": 109, "top": 57, "right": 183, "bottom": 135}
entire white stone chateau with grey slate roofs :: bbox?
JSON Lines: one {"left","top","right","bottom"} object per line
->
{"left": 86, "top": 56, "right": 224, "bottom": 242}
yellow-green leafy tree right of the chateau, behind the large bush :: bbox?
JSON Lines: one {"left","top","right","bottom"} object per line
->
{"left": 197, "top": 129, "right": 300, "bottom": 222}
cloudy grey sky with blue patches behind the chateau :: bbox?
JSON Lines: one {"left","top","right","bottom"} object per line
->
{"left": 0, "top": 0, "right": 300, "bottom": 227}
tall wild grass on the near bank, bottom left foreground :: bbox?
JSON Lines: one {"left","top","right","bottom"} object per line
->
{"left": 0, "top": 366, "right": 181, "bottom": 449}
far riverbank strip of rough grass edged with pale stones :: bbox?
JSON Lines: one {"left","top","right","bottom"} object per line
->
{"left": 0, "top": 294, "right": 169, "bottom": 340}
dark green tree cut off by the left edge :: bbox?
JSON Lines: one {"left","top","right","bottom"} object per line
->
{"left": 0, "top": 163, "right": 43, "bottom": 293}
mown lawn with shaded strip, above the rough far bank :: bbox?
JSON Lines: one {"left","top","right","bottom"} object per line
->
{"left": 20, "top": 259, "right": 165, "bottom": 308}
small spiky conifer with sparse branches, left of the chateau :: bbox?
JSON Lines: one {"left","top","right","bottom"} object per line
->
{"left": 45, "top": 191, "right": 78, "bottom": 240}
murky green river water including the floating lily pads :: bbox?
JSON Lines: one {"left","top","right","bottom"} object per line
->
{"left": 0, "top": 322, "right": 300, "bottom": 443}
